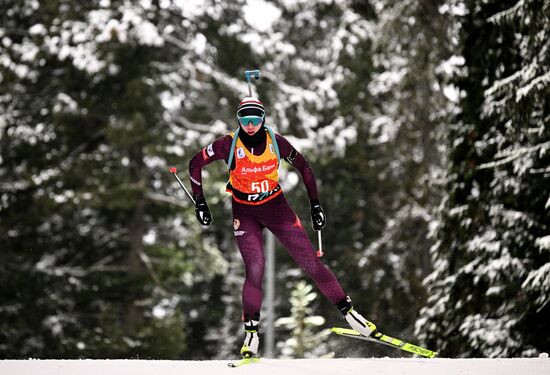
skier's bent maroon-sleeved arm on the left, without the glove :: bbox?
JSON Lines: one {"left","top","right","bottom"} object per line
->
{"left": 189, "top": 135, "right": 233, "bottom": 199}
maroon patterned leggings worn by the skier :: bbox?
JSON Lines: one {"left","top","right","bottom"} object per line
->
{"left": 233, "top": 194, "right": 346, "bottom": 317}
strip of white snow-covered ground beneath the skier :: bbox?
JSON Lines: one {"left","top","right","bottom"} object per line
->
{"left": 0, "top": 358, "right": 550, "bottom": 375}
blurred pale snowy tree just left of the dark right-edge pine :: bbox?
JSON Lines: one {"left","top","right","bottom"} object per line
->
{"left": 359, "top": 0, "right": 453, "bottom": 336}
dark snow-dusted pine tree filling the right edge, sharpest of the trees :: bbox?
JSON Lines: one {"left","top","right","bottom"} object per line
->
{"left": 416, "top": 0, "right": 550, "bottom": 357}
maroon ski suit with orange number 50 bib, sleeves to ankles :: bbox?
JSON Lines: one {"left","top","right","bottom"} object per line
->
{"left": 189, "top": 128, "right": 346, "bottom": 317}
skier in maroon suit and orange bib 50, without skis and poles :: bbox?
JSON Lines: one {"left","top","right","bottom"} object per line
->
{"left": 189, "top": 97, "right": 376, "bottom": 358}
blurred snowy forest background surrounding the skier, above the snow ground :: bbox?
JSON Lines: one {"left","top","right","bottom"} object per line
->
{"left": 0, "top": 0, "right": 550, "bottom": 359}
